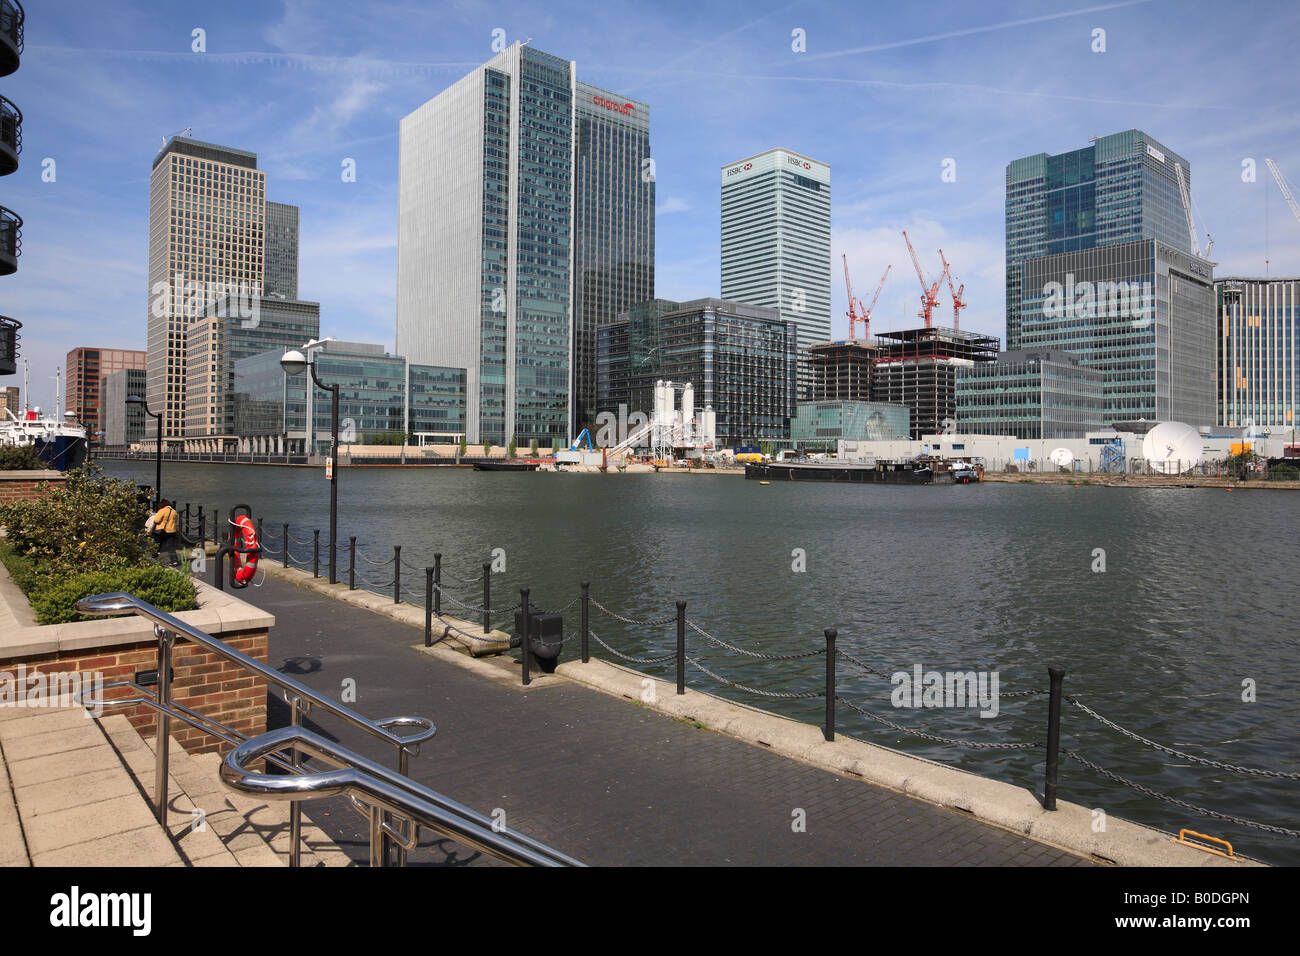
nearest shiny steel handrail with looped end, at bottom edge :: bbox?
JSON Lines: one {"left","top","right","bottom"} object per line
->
{"left": 221, "top": 726, "right": 584, "bottom": 866}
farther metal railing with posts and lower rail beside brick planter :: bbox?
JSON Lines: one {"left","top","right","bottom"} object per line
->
{"left": 77, "top": 592, "right": 437, "bottom": 866}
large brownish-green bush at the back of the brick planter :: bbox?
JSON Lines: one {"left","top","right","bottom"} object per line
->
{"left": 0, "top": 464, "right": 148, "bottom": 575}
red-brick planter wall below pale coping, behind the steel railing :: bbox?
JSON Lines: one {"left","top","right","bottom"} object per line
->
{"left": 9, "top": 630, "right": 268, "bottom": 753}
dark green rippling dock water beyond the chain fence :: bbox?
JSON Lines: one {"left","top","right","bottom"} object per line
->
{"left": 104, "top": 462, "right": 1300, "bottom": 864}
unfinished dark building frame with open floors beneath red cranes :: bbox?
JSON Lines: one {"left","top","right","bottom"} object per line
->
{"left": 810, "top": 328, "right": 1001, "bottom": 438}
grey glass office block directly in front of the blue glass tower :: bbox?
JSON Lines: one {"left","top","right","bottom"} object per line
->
{"left": 1019, "top": 239, "right": 1217, "bottom": 427}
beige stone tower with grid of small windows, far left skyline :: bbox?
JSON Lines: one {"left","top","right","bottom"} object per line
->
{"left": 146, "top": 137, "right": 267, "bottom": 438}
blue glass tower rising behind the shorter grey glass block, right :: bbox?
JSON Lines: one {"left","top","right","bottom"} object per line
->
{"left": 1006, "top": 130, "right": 1192, "bottom": 350}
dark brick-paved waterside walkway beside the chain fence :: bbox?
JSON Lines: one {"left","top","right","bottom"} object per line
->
{"left": 241, "top": 578, "right": 1088, "bottom": 866}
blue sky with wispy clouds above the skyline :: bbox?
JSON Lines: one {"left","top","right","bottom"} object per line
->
{"left": 0, "top": 0, "right": 1300, "bottom": 408}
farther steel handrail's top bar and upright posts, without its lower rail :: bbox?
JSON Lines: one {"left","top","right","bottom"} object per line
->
{"left": 77, "top": 591, "right": 437, "bottom": 866}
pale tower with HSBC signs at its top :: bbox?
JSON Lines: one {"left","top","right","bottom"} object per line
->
{"left": 722, "top": 150, "right": 831, "bottom": 397}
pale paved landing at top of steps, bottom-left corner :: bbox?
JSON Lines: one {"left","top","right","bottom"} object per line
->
{"left": 0, "top": 706, "right": 186, "bottom": 866}
